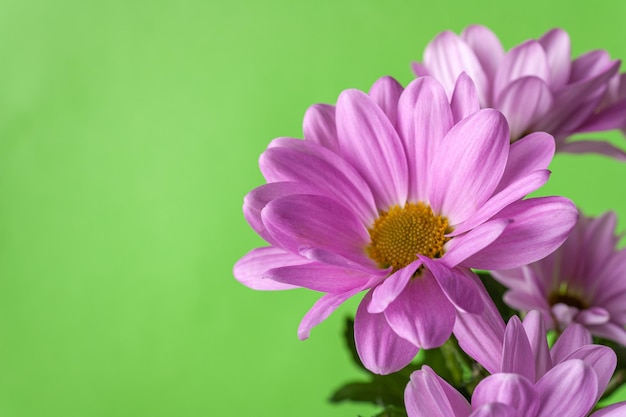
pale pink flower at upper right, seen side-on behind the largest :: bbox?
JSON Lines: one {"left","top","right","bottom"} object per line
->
{"left": 413, "top": 25, "right": 626, "bottom": 160}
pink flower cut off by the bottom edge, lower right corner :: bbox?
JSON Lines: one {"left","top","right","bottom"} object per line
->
{"left": 405, "top": 311, "right": 626, "bottom": 417}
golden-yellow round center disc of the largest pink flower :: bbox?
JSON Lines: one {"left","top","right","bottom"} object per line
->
{"left": 367, "top": 202, "right": 451, "bottom": 271}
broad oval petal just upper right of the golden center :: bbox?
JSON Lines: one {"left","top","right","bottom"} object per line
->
{"left": 427, "top": 109, "right": 509, "bottom": 226}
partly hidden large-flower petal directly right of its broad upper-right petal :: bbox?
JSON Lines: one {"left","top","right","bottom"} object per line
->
{"left": 496, "top": 132, "right": 555, "bottom": 192}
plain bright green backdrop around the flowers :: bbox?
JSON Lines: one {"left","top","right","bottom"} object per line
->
{"left": 0, "top": 0, "right": 626, "bottom": 417}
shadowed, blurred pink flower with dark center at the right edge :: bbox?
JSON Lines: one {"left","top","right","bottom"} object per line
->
{"left": 493, "top": 212, "right": 626, "bottom": 345}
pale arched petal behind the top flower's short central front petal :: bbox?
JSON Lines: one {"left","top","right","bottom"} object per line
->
{"left": 493, "top": 40, "right": 550, "bottom": 102}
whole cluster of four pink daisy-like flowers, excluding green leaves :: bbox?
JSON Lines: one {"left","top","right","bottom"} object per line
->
{"left": 234, "top": 26, "right": 626, "bottom": 417}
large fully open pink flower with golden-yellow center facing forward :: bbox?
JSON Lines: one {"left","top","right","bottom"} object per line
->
{"left": 234, "top": 76, "right": 577, "bottom": 373}
